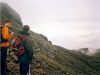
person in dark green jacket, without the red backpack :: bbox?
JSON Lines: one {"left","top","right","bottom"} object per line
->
{"left": 15, "top": 25, "right": 33, "bottom": 75}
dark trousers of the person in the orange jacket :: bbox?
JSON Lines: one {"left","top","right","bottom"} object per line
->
{"left": 1, "top": 47, "right": 7, "bottom": 75}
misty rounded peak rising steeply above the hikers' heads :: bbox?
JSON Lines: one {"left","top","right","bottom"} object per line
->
{"left": 0, "top": 3, "right": 22, "bottom": 28}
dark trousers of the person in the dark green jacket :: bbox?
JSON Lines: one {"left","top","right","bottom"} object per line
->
{"left": 20, "top": 62, "right": 29, "bottom": 75}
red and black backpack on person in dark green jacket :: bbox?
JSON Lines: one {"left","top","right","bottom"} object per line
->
{"left": 12, "top": 35, "right": 25, "bottom": 56}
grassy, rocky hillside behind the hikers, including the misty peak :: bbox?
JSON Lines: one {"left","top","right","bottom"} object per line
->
{"left": 0, "top": 3, "right": 100, "bottom": 75}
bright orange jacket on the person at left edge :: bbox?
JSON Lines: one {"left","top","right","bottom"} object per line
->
{"left": 0, "top": 26, "right": 13, "bottom": 47}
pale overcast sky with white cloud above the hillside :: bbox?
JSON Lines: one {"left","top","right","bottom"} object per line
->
{"left": 2, "top": 0, "right": 100, "bottom": 49}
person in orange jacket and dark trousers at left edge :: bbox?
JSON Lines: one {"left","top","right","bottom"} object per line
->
{"left": 0, "top": 20, "right": 14, "bottom": 75}
